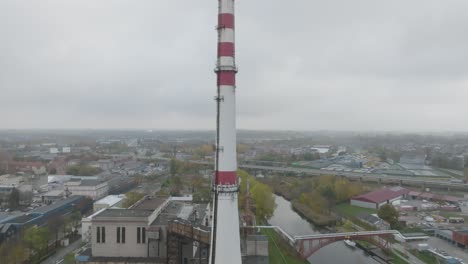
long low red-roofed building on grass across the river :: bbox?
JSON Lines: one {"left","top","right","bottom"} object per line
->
{"left": 351, "top": 187, "right": 410, "bottom": 209}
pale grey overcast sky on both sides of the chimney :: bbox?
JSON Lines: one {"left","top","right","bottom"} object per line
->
{"left": 0, "top": 0, "right": 468, "bottom": 131}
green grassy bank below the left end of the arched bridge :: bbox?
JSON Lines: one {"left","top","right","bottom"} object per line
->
{"left": 262, "top": 229, "right": 309, "bottom": 264}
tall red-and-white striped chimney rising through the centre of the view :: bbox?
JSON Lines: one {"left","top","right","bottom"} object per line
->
{"left": 210, "top": 0, "right": 242, "bottom": 264}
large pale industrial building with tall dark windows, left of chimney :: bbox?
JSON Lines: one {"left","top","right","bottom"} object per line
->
{"left": 77, "top": 197, "right": 211, "bottom": 263}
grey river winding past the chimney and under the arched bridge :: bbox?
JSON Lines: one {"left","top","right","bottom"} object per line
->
{"left": 269, "top": 195, "right": 378, "bottom": 264}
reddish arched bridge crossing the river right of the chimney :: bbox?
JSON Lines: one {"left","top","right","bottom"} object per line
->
{"left": 251, "top": 226, "right": 400, "bottom": 259}
